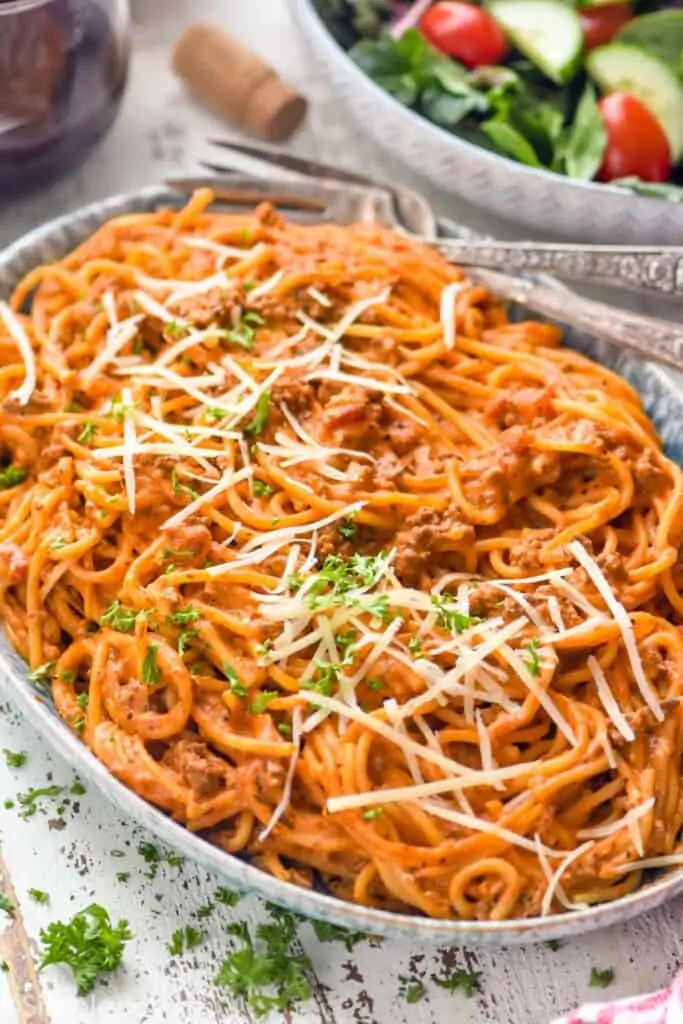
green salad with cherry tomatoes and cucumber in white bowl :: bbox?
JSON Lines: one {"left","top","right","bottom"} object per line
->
{"left": 313, "top": 0, "right": 683, "bottom": 203}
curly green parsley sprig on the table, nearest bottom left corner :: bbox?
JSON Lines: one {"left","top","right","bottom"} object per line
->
{"left": 40, "top": 903, "right": 133, "bottom": 995}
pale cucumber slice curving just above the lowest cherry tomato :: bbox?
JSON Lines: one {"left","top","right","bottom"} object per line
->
{"left": 586, "top": 43, "right": 683, "bottom": 162}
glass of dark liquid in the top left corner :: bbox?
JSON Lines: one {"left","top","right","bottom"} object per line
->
{"left": 0, "top": 0, "right": 128, "bottom": 197}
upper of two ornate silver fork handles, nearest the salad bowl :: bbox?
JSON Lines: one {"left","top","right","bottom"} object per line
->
{"left": 436, "top": 240, "right": 683, "bottom": 297}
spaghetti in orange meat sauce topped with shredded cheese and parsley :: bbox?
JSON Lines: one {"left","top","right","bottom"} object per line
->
{"left": 0, "top": 191, "right": 683, "bottom": 920}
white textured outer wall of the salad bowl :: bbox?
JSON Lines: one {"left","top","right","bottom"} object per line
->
{"left": 290, "top": 0, "right": 683, "bottom": 245}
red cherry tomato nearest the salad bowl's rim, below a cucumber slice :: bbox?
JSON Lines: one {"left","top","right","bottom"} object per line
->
{"left": 598, "top": 92, "right": 671, "bottom": 181}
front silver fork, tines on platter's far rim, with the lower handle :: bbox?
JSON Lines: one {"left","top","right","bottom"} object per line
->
{"left": 168, "top": 143, "right": 683, "bottom": 369}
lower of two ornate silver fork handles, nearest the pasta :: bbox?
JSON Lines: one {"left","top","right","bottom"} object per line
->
{"left": 470, "top": 268, "right": 683, "bottom": 370}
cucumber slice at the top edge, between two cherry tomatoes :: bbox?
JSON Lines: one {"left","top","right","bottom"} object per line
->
{"left": 488, "top": 0, "right": 584, "bottom": 85}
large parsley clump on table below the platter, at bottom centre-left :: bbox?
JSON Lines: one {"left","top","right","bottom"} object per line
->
{"left": 214, "top": 908, "right": 311, "bottom": 1017}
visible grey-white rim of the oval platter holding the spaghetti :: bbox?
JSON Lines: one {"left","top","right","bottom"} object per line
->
{"left": 0, "top": 187, "right": 683, "bottom": 945}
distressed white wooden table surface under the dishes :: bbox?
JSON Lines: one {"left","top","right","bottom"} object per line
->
{"left": 0, "top": 0, "right": 683, "bottom": 1024}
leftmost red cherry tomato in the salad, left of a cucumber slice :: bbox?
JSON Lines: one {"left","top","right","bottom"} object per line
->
{"left": 420, "top": 0, "right": 508, "bottom": 68}
